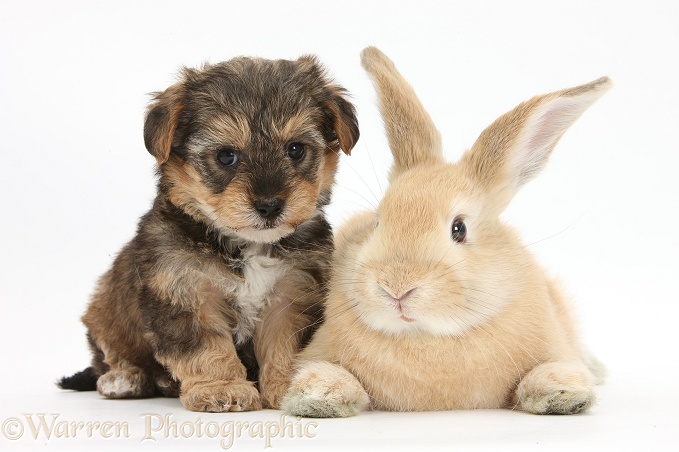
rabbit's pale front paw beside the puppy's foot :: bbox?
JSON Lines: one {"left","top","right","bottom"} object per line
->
{"left": 281, "top": 361, "right": 370, "bottom": 417}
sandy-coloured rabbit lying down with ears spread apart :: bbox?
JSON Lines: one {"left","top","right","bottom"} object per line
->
{"left": 282, "top": 47, "right": 612, "bottom": 417}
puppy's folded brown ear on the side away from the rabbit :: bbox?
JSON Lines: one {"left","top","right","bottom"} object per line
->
{"left": 144, "top": 82, "right": 186, "bottom": 165}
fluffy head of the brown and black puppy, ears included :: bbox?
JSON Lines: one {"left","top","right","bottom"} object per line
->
{"left": 144, "top": 56, "right": 359, "bottom": 243}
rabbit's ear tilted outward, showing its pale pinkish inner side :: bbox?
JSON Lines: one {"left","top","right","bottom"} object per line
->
{"left": 461, "top": 77, "right": 612, "bottom": 214}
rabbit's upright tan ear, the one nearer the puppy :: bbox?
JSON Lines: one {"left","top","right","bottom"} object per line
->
{"left": 361, "top": 47, "right": 443, "bottom": 180}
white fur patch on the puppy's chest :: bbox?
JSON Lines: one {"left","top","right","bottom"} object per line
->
{"left": 233, "top": 245, "right": 288, "bottom": 344}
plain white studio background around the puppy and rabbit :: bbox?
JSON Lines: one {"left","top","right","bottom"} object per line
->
{"left": 0, "top": 0, "right": 679, "bottom": 450}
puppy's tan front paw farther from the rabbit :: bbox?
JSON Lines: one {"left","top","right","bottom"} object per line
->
{"left": 180, "top": 381, "right": 262, "bottom": 413}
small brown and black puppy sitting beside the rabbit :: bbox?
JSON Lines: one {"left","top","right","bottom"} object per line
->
{"left": 59, "top": 56, "right": 359, "bottom": 412}
